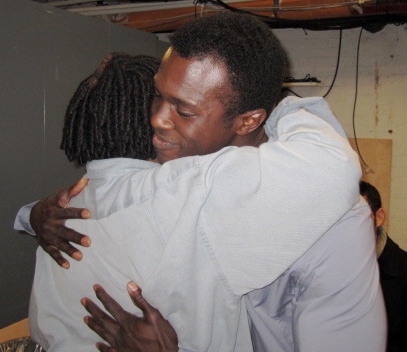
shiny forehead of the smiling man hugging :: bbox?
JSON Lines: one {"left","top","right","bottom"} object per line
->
{"left": 155, "top": 48, "right": 230, "bottom": 103}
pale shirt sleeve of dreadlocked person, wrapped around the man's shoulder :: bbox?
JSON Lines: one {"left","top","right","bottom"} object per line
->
{"left": 198, "top": 109, "right": 361, "bottom": 294}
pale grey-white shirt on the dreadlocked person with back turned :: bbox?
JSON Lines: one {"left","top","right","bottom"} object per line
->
{"left": 23, "top": 98, "right": 361, "bottom": 352}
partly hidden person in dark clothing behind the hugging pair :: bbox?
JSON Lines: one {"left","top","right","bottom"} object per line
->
{"left": 360, "top": 181, "right": 407, "bottom": 352}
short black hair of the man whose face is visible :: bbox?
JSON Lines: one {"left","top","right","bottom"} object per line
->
{"left": 170, "top": 11, "right": 286, "bottom": 120}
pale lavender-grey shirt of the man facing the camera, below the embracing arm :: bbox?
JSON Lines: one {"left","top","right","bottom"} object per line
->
{"left": 245, "top": 197, "right": 387, "bottom": 352}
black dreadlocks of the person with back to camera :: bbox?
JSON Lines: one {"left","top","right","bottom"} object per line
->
{"left": 61, "top": 53, "right": 160, "bottom": 165}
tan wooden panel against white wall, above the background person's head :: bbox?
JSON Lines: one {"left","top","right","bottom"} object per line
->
{"left": 349, "top": 138, "right": 393, "bottom": 229}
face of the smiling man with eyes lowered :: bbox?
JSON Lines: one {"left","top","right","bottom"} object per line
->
{"left": 151, "top": 48, "right": 242, "bottom": 163}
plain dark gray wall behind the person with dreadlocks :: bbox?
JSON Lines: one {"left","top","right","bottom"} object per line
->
{"left": 0, "top": 0, "right": 167, "bottom": 328}
